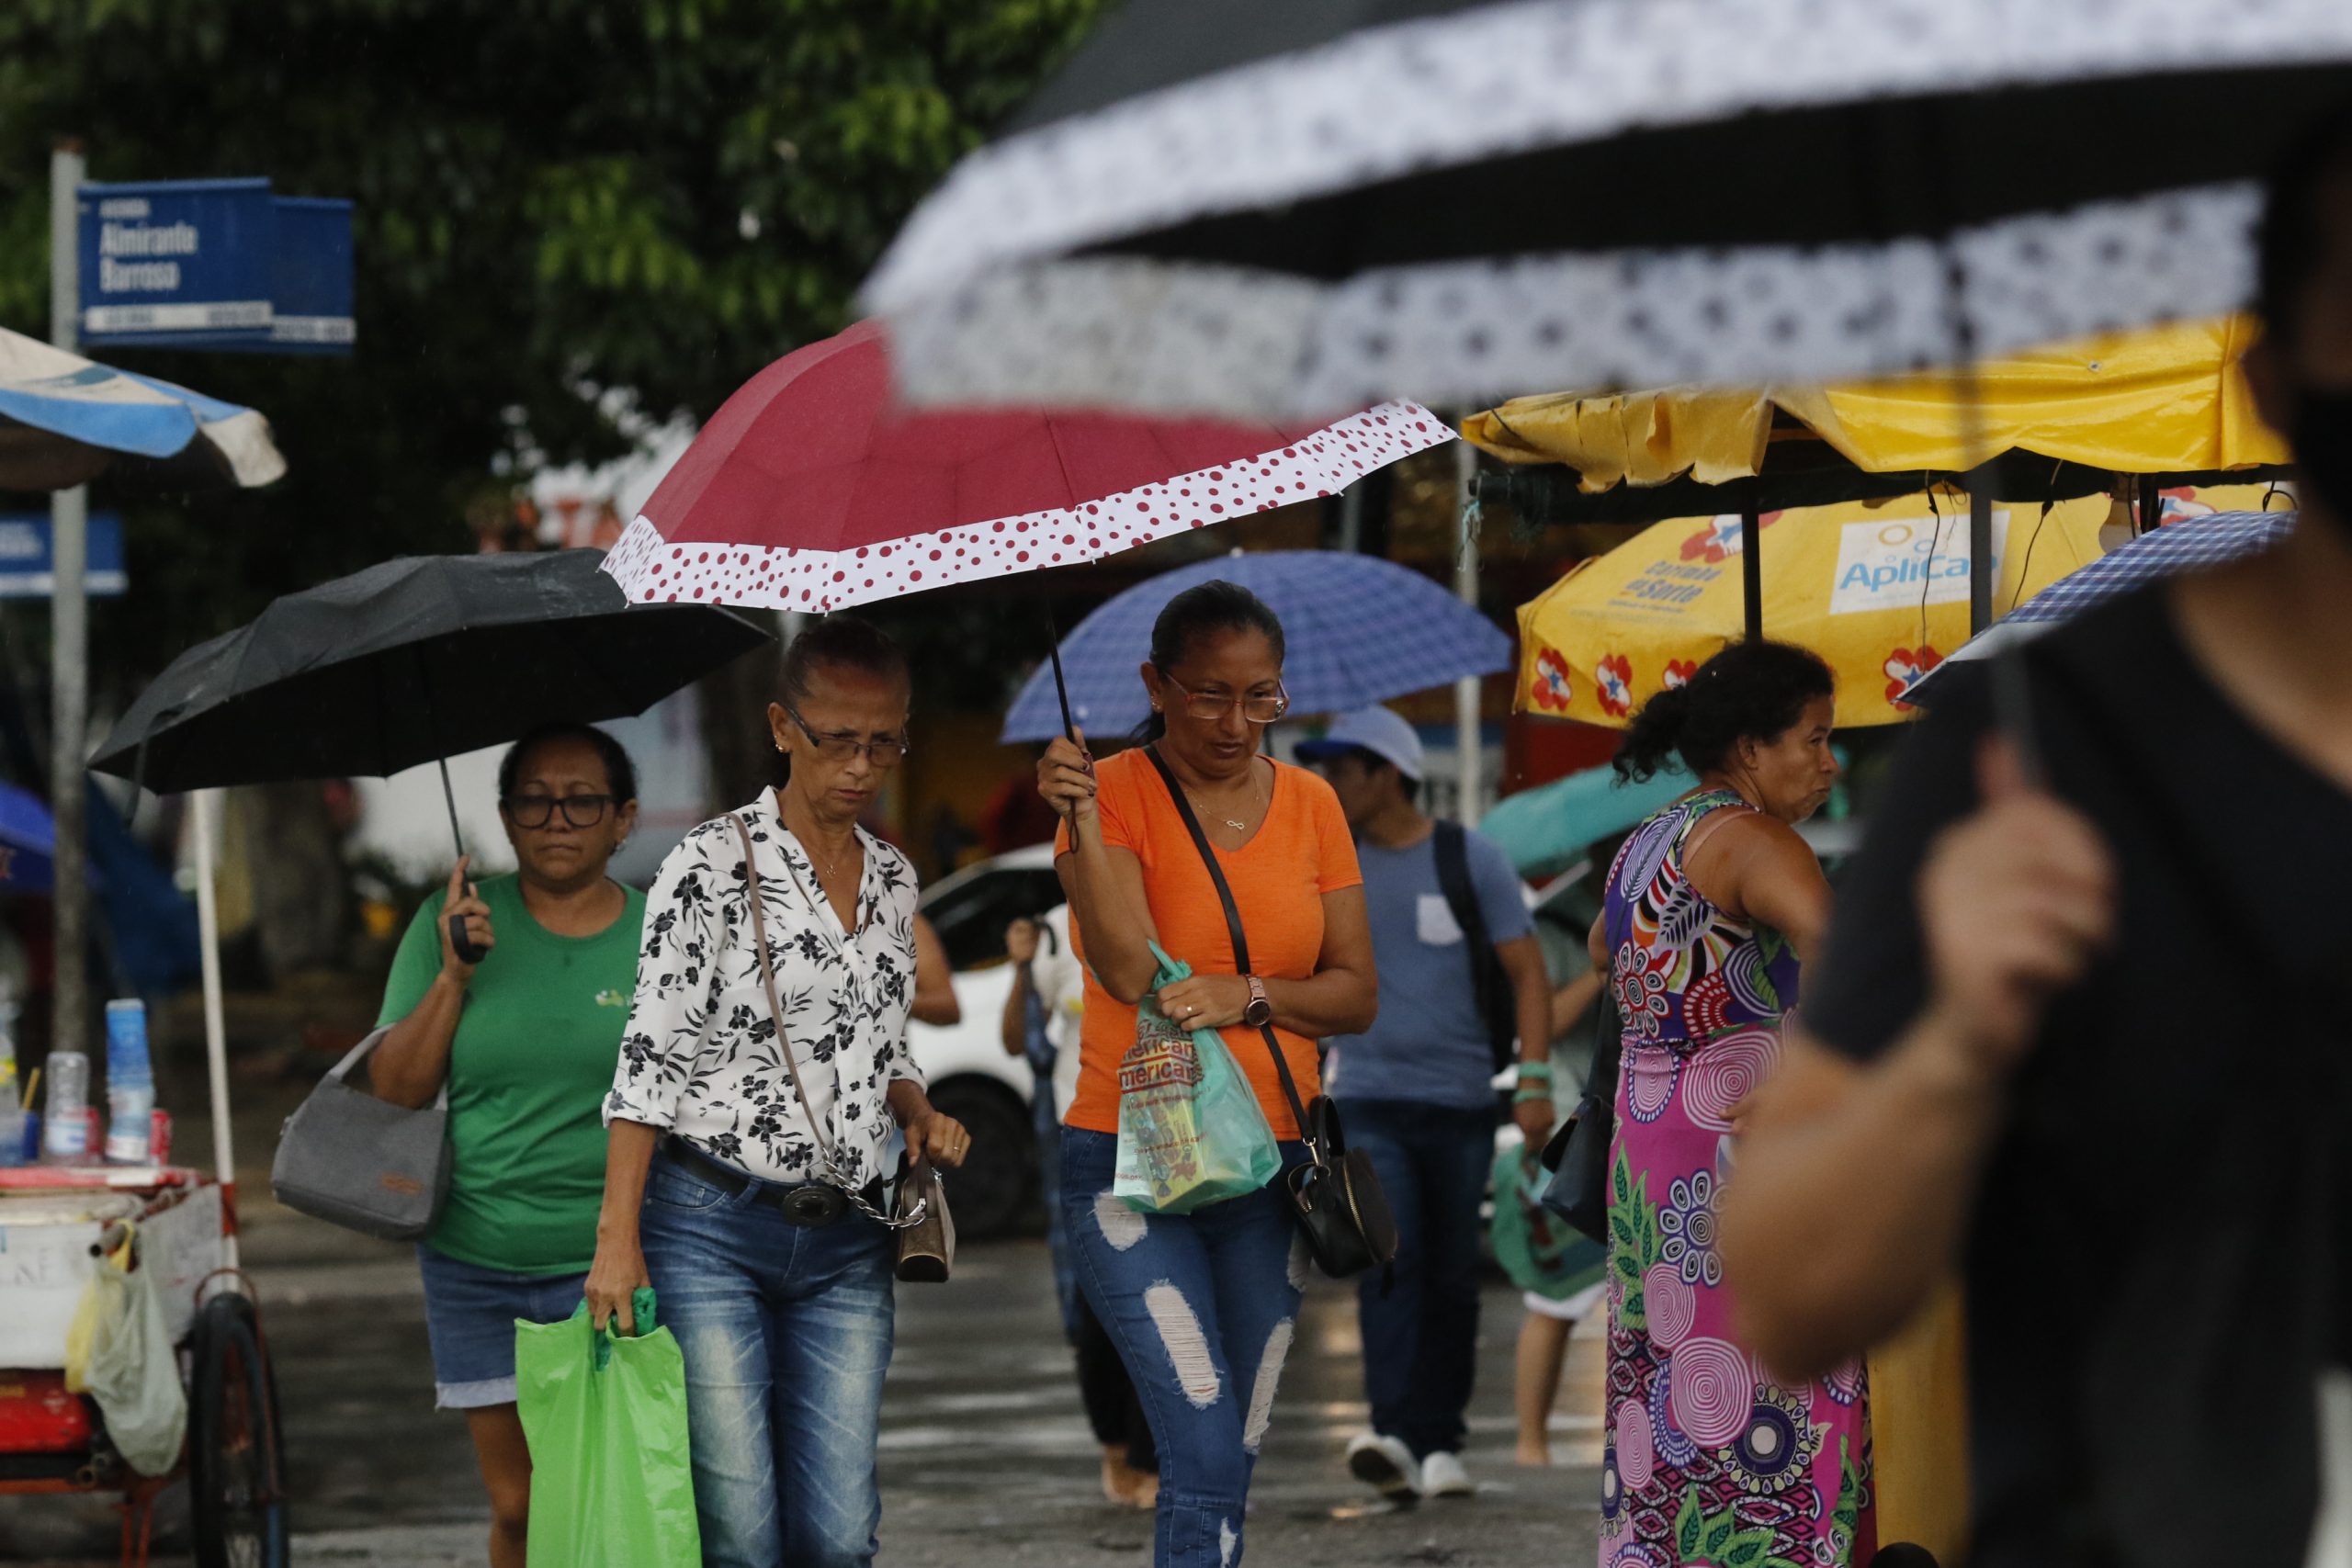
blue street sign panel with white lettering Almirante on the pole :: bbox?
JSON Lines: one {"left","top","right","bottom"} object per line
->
{"left": 77, "top": 179, "right": 277, "bottom": 345}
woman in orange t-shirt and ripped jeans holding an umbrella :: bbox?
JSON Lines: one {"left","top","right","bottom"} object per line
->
{"left": 1037, "top": 583, "right": 1378, "bottom": 1568}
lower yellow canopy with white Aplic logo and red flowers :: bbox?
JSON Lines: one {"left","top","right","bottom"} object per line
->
{"left": 1520, "top": 484, "right": 2263, "bottom": 727}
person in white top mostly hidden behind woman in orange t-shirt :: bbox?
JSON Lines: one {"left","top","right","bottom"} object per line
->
{"left": 1004, "top": 903, "right": 1159, "bottom": 1509}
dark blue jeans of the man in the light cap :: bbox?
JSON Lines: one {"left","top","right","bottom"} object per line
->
{"left": 1339, "top": 1100, "right": 1494, "bottom": 1460}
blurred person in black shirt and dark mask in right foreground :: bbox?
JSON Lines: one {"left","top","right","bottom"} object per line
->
{"left": 1724, "top": 113, "right": 2352, "bottom": 1568}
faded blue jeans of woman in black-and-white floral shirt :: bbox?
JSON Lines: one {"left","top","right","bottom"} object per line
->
{"left": 639, "top": 1155, "right": 896, "bottom": 1568}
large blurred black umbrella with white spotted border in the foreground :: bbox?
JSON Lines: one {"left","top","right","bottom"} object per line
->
{"left": 865, "top": 0, "right": 2352, "bottom": 413}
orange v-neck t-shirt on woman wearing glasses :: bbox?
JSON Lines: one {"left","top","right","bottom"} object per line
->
{"left": 1054, "top": 748, "right": 1364, "bottom": 1138}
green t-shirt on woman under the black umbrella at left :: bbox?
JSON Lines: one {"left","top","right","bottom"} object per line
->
{"left": 377, "top": 874, "right": 644, "bottom": 1274}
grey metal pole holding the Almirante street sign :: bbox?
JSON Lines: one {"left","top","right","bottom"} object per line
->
{"left": 50, "top": 141, "right": 89, "bottom": 1051}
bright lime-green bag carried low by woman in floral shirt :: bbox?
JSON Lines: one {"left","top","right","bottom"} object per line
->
{"left": 515, "top": 1288, "right": 703, "bottom": 1568}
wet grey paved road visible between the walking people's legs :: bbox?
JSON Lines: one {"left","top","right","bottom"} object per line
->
{"left": 0, "top": 1100, "right": 1600, "bottom": 1568}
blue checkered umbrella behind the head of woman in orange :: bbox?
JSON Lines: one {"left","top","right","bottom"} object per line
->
{"left": 1004, "top": 550, "right": 1510, "bottom": 743}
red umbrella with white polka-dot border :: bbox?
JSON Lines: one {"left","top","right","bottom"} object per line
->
{"left": 605, "top": 322, "right": 1453, "bottom": 611}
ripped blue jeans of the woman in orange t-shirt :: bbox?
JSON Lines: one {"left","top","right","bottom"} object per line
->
{"left": 1061, "top": 1126, "right": 1307, "bottom": 1568}
